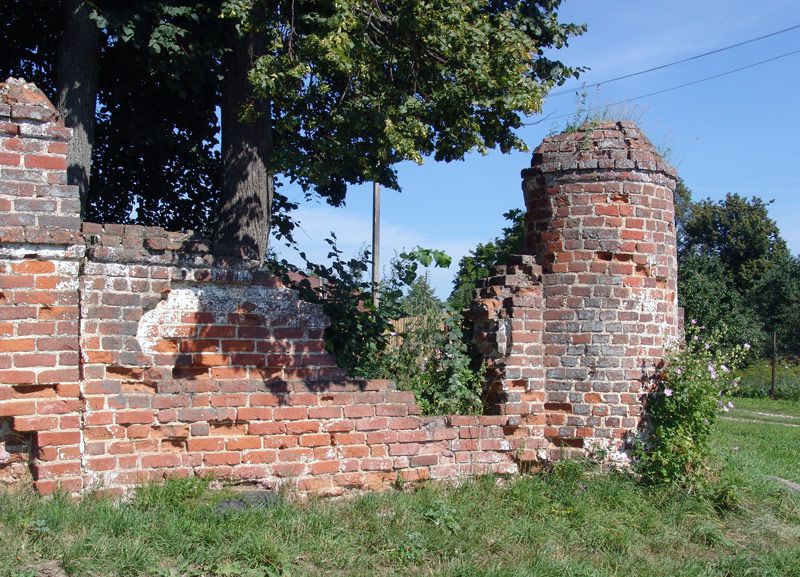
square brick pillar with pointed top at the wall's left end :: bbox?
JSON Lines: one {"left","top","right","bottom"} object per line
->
{"left": 0, "top": 79, "right": 83, "bottom": 493}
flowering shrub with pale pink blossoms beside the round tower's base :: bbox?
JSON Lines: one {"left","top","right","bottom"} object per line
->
{"left": 636, "top": 321, "right": 749, "bottom": 486}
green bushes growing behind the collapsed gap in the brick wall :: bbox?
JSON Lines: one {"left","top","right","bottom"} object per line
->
{"left": 276, "top": 235, "right": 483, "bottom": 414}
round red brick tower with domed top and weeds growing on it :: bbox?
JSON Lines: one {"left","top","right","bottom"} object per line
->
{"left": 522, "top": 122, "right": 678, "bottom": 460}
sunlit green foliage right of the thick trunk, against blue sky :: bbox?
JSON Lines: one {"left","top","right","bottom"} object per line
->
{"left": 184, "top": 0, "right": 583, "bottom": 252}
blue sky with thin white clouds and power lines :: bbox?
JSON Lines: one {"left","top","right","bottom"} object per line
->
{"left": 281, "top": 0, "right": 800, "bottom": 297}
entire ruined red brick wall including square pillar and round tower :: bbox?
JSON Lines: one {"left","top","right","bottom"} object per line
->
{"left": 0, "top": 80, "right": 675, "bottom": 495}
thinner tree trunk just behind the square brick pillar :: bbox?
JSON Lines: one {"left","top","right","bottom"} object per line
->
{"left": 56, "top": 0, "right": 102, "bottom": 217}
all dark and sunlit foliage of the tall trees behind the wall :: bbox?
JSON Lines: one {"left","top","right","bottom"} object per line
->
{"left": 0, "top": 0, "right": 584, "bottom": 258}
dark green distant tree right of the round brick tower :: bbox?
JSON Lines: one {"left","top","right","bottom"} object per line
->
{"left": 675, "top": 183, "right": 800, "bottom": 355}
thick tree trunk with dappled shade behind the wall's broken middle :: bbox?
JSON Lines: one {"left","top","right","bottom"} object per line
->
{"left": 214, "top": 18, "right": 274, "bottom": 264}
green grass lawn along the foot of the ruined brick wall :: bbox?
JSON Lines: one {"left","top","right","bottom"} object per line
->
{"left": 0, "top": 399, "right": 800, "bottom": 577}
